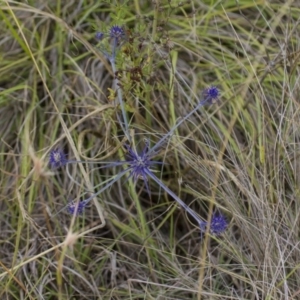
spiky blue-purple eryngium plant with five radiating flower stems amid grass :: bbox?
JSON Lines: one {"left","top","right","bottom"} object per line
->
{"left": 49, "top": 25, "right": 228, "bottom": 235}
